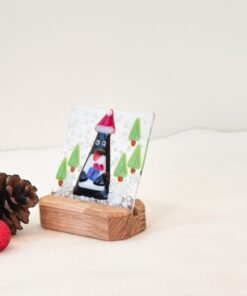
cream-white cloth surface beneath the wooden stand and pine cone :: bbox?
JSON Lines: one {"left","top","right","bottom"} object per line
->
{"left": 0, "top": 130, "right": 247, "bottom": 296}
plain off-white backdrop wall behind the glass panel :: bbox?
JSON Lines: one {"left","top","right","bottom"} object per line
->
{"left": 0, "top": 0, "right": 247, "bottom": 149}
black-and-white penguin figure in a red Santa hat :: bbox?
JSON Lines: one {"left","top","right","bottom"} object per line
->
{"left": 73, "top": 110, "right": 115, "bottom": 200}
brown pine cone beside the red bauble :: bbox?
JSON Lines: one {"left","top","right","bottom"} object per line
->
{"left": 0, "top": 173, "right": 39, "bottom": 234}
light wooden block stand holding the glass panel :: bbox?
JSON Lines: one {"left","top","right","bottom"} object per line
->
{"left": 40, "top": 195, "right": 146, "bottom": 241}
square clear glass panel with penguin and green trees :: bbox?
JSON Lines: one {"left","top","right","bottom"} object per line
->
{"left": 53, "top": 106, "right": 154, "bottom": 208}
